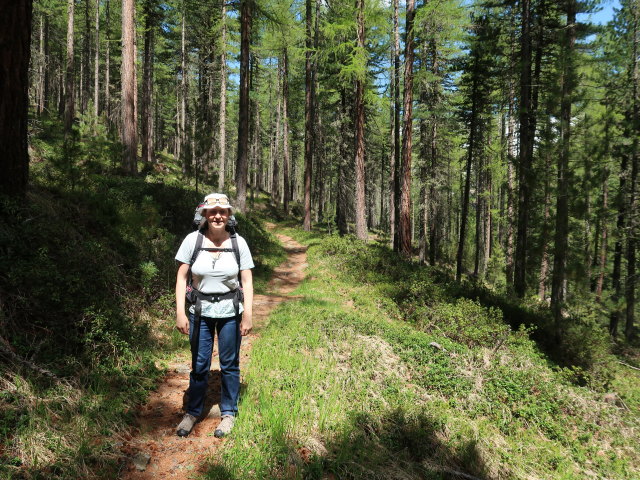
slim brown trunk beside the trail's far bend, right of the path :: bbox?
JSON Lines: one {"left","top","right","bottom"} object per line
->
{"left": 303, "top": 0, "right": 313, "bottom": 231}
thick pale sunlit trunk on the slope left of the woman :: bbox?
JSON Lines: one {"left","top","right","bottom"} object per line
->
{"left": 121, "top": 0, "right": 138, "bottom": 175}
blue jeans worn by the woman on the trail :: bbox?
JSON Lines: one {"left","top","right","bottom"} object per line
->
{"left": 187, "top": 314, "right": 242, "bottom": 417}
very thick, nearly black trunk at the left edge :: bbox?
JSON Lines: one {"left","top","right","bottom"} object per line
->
{"left": 0, "top": 0, "right": 33, "bottom": 197}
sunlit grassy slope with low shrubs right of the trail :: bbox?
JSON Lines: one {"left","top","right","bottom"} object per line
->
{"left": 207, "top": 226, "right": 640, "bottom": 479}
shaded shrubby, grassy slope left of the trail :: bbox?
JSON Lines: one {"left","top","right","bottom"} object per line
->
{"left": 0, "top": 120, "right": 284, "bottom": 479}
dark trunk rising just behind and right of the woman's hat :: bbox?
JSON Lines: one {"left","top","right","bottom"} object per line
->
{"left": 236, "top": 0, "right": 253, "bottom": 212}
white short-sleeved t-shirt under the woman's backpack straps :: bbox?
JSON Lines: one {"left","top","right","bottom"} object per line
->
{"left": 176, "top": 231, "right": 254, "bottom": 318}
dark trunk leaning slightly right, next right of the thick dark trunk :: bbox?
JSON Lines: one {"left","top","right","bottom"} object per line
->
{"left": 551, "top": 0, "right": 576, "bottom": 343}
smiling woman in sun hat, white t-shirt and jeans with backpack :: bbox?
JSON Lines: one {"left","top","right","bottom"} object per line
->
{"left": 176, "top": 193, "right": 254, "bottom": 438}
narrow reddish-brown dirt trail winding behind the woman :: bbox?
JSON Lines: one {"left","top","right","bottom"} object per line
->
{"left": 120, "top": 224, "right": 307, "bottom": 480}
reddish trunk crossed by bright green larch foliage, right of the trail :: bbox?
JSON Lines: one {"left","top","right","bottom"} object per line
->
{"left": 354, "top": 0, "right": 367, "bottom": 240}
